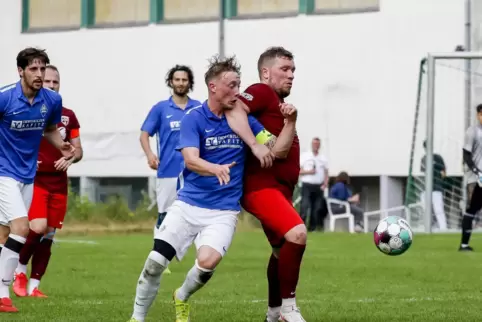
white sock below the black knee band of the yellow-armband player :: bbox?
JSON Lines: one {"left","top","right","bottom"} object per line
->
{"left": 132, "top": 251, "right": 169, "bottom": 322}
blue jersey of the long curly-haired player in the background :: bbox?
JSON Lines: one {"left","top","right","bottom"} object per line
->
{"left": 141, "top": 96, "right": 201, "bottom": 178}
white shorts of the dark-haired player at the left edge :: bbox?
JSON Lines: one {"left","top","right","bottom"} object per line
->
{"left": 0, "top": 177, "right": 33, "bottom": 226}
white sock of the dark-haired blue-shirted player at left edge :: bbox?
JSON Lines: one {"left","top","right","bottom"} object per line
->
{"left": 0, "top": 234, "right": 26, "bottom": 298}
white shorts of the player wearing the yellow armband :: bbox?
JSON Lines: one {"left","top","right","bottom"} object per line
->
{"left": 154, "top": 200, "right": 239, "bottom": 260}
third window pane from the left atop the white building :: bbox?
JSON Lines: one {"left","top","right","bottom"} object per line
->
{"left": 164, "top": 0, "right": 220, "bottom": 20}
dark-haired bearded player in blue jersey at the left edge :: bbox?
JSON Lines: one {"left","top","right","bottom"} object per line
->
{"left": 0, "top": 48, "right": 75, "bottom": 312}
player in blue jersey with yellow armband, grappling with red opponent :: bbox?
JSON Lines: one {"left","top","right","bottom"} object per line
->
{"left": 126, "top": 58, "right": 294, "bottom": 322}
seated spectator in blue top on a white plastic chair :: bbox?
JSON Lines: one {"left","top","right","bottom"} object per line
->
{"left": 329, "top": 172, "right": 364, "bottom": 232}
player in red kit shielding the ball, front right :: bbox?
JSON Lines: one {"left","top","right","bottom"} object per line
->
{"left": 227, "top": 47, "right": 306, "bottom": 322}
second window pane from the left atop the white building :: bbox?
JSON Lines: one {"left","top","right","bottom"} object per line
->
{"left": 95, "top": 0, "right": 150, "bottom": 25}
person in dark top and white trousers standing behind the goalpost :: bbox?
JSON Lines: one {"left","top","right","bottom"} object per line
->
{"left": 420, "top": 141, "right": 447, "bottom": 231}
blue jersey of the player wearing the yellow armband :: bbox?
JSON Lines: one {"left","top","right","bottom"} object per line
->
{"left": 178, "top": 102, "right": 264, "bottom": 211}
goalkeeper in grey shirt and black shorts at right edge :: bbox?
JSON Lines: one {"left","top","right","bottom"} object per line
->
{"left": 459, "top": 104, "right": 482, "bottom": 251}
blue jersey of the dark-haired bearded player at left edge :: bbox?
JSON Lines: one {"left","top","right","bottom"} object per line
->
{"left": 0, "top": 82, "right": 62, "bottom": 184}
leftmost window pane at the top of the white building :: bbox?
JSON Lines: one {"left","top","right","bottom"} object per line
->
{"left": 28, "top": 0, "right": 81, "bottom": 29}
